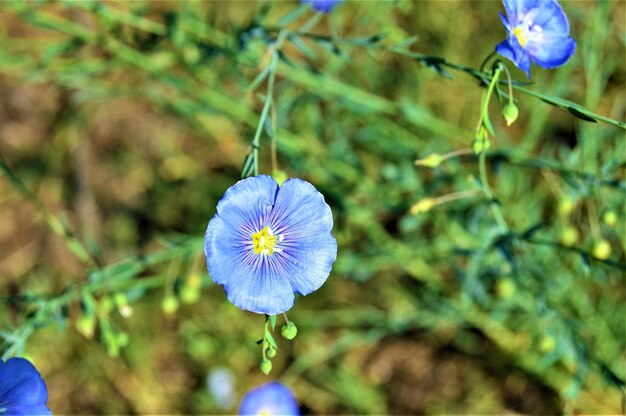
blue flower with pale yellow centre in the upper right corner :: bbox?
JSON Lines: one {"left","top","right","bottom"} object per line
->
{"left": 496, "top": 0, "right": 576, "bottom": 78}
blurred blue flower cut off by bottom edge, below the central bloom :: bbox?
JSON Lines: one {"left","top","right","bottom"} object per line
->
{"left": 239, "top": 381, "right": 300, "bottom": 416}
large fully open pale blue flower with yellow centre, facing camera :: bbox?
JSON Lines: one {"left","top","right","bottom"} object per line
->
{"left": 204, "top": 175, "right": 337, "bottom": 315}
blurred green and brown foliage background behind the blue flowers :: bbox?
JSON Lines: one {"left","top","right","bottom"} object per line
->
{"left": 0, "top": 1, "right": 626, "bottom": 414}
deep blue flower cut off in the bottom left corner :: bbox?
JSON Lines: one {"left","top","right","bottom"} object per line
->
{"left": 0, "top": 358, "right": 52, "bottom": 415}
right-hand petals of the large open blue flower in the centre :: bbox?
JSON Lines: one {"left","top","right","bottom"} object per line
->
{"left": 270, "top": 178, "right": 337, "bottom": 295}
